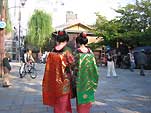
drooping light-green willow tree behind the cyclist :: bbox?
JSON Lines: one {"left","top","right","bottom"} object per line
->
{"left": 25, "top": 10, "right": 53, "bottom": 49}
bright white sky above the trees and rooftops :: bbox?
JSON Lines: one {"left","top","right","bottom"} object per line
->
{"left": 9, "top": 0, "right": 135, "bottom": 28}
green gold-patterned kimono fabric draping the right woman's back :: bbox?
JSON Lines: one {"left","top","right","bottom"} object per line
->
{"left": 76, "top": 52, "right": 98, "bottom": 104}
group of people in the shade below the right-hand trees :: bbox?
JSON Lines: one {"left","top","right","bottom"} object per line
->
{"left": 105, "top": 43, "right": 148, "bottom": 77}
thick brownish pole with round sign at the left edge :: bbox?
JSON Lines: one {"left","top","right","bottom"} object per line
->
{"left": 0, "top": 0, "right": 6, "bottom": 77}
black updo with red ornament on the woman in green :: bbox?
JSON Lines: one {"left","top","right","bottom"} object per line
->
{"left": 76, "top": 32, "right": 88, "bottom": 45}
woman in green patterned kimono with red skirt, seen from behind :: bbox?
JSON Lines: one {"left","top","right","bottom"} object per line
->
{"left": 74, "top": 32, "right": 98, "bottom": 113}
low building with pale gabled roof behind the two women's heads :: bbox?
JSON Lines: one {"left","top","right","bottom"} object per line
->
{"left": 53, "top": 20, "right": 103, "bottom": 64}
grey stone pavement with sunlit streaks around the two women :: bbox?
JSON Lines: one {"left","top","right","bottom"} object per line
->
{"left": 0, "top": 63, "right": 151, "bottom": 113}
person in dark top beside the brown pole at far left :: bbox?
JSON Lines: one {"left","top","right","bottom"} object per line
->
{"left": 3, "top": 53, "right": 11, "bottom": 87}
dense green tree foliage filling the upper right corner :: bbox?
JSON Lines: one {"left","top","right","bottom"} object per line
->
{"left": 95, "top": 0, "right": 151, "bottom": 46}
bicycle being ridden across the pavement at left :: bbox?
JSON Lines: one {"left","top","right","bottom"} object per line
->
{"left": 19, "top": 63, "right": 37, "bottom": 79}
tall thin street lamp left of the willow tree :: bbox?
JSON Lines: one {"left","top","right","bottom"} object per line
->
{"left": 18, "top": 0, "right": 27, "bottom": 62}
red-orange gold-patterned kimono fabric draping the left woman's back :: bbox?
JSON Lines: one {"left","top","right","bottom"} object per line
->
{"left": 42, "top": 46, "right": 72, "bottom": 111}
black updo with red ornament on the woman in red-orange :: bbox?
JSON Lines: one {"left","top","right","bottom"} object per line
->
{"left": 56, "top": 31, "right": 69, "bottom": 42}
